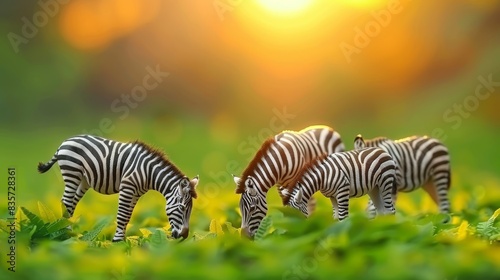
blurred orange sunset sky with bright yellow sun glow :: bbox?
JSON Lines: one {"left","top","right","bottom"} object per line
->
{"left": 0, "top": 0, "right": 500, "bottom": 129}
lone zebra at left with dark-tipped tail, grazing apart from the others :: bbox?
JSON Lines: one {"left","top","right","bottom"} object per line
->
{"left": 38, "top": 135, "right": 198, "bottom": 241}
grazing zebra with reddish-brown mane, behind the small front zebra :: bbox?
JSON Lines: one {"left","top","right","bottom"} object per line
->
{"left": 234, "top": 126, "right": 344, "bottom": 238}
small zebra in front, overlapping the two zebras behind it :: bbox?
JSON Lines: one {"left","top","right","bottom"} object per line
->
{"left": 284, "top": 148, "right": 396, "bottom": 220}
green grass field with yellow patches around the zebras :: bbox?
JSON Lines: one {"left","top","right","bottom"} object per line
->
{"left": 0, "top": 112, "right": 500, "bottom": 280}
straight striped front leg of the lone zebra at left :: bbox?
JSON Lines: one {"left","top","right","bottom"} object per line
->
{"left": 113, "top": 188, "right": 139, "bottom": 242}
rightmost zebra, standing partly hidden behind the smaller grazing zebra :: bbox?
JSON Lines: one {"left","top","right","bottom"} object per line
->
{"left": 354, "top": 135, "right": 451, "bottom": 215}
